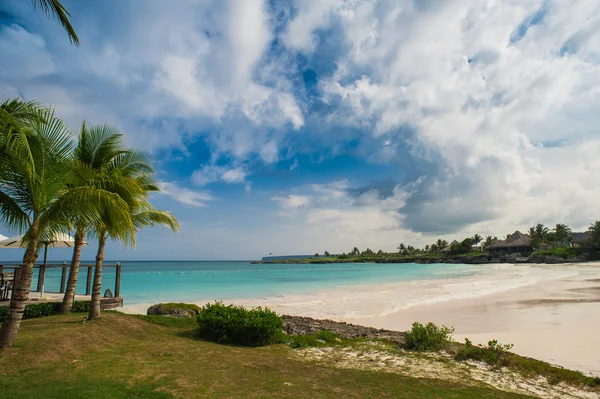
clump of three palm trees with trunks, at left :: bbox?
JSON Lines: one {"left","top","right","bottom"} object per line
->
{"left": 0, "top": 99, "right": 178, "bottom": 347}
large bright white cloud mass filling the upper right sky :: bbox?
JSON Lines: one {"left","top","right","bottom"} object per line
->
{"left": 289, "top": 0, "right": 600, "bottom": 234}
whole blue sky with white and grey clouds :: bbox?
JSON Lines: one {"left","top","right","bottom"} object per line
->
{"left": 0, "top": 0, "right": 600, "bottom": 260}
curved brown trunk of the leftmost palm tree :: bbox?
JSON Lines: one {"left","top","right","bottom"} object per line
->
{"left": 0, "top": 221, "right": 38, "bottom": 348}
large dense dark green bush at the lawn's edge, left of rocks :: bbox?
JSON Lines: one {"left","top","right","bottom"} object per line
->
{"left": 197, "top": 302, "right": 283, "bottom": 346}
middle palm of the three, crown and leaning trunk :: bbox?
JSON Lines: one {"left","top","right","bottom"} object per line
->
{"left": 60, "top": 122, "right": 149, "bottom": 313}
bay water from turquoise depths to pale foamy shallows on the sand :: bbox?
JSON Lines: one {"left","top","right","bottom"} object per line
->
{"left": 28, "top": 261, "right": 576, "bottom": 319}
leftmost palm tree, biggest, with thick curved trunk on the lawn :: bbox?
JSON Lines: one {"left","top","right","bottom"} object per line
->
{"left": 0, "top": 99, "right": 127, "bottom": 347}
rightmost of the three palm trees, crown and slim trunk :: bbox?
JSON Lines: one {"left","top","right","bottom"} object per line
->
{"left": 89, "top": 158, "right": 179, "bottom": 320}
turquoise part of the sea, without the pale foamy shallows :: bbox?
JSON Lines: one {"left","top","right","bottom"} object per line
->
{"left": 32, "top": 261, "right": 477, "bottom": 305}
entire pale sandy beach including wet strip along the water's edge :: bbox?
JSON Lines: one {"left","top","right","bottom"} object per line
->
{"left": 121, "top": 262, "right": 600, "bottom": 376}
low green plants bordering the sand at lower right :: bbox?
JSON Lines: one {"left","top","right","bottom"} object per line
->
{"left": 454, "top": 339, "right": 600, "bottom": 388}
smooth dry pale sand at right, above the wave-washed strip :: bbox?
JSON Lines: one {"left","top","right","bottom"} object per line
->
{"left": 352, "top": 264, "right": 600, "bottom": 376}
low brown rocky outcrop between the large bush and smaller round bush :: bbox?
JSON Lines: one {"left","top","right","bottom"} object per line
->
{"left": 281, "top": 315, "right": 405, "bottom": 344}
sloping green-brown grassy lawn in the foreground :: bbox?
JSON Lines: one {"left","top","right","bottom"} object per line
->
{"left": 0, "top": 312, "right": 526, "bottom": 399}
